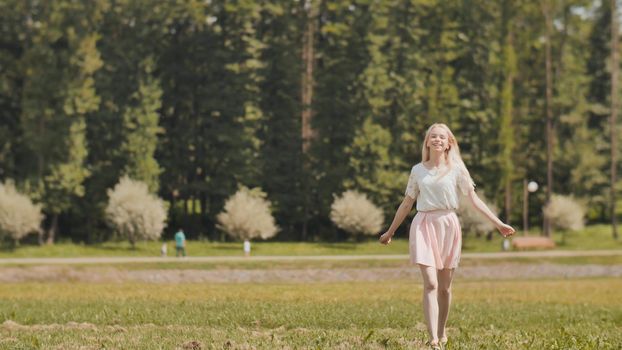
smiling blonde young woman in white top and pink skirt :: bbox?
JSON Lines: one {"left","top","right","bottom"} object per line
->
{"left": 380, "top": 124, "right": 515, "bottom": 349}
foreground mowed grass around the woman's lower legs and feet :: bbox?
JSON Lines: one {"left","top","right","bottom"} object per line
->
{"left": 0, "top": 278, "right": 622, "bottom": 349}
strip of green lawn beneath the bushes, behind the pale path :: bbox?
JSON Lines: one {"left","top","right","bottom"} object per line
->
{"left": 0, "top": 225, "right": 622, "bottom": 258}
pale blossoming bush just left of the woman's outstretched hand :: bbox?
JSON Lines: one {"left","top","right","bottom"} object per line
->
{"left": 330, "top": 190, "right": 384, "bottom": 235}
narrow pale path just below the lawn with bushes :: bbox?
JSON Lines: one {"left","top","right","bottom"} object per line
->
{"left": 0, "top": 249, "right": 622, "bottom": 265}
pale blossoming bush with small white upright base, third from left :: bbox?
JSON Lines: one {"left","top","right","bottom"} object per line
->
{"left": 216, "top": 187, "right": 279, "bottom": 254}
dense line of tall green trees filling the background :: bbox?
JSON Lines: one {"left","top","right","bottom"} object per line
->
{"left": 0, "top": 0, "right": 622, "bottom": 242}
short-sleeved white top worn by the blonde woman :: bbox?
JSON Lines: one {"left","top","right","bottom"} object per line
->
{"left": 405, "top": 163, "right": 474, "bottom": 211}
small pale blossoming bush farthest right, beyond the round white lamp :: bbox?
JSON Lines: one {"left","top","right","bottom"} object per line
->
{"left": 543, "top": 194, "right": 585, "bottom": 231}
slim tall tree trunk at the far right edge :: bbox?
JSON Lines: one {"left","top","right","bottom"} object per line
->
{"left": 609, "top": 0, "right": 620, "bottom": 240}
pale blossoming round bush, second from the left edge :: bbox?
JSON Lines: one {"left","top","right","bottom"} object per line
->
{"left": 106, "top": 176, "right": 166, "bottom": 246}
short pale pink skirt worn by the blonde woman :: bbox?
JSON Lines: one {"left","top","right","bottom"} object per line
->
{"left": 409, "top": 210, "right": 462, "bottom": 270}
